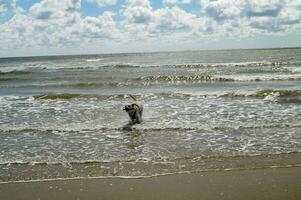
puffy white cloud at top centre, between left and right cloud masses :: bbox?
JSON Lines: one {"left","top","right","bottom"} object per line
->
{"left": 122, "top": 0, "right": 210, "bottom": 39}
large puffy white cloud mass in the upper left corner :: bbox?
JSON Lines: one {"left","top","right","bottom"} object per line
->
{"left": 0, "top": 0, "right": 119, "bottom": 48}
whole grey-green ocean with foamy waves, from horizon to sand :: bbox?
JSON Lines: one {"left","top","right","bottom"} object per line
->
{"left": 0, "top": 48, "right": 301, "bottom": 182}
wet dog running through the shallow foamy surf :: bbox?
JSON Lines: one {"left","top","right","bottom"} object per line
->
{"left": 123, "top": 95, "right": 143, "bottom": 129}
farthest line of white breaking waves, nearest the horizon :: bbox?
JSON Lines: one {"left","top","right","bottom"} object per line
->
{"left": 0, "top": 59, "right": 301, "bottom": 74}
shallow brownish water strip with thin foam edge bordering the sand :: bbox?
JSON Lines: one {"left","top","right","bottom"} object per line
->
{"left": 0, "top": 153, "right": 301, "bottom": 185}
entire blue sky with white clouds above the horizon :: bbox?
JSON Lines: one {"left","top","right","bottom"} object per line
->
{"left": 0, "top": 0, "right": 301, "bottom": 57}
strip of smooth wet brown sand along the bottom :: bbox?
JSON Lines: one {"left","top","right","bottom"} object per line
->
{"left": 0, "top": 167, "right": 301, "bottom": 200}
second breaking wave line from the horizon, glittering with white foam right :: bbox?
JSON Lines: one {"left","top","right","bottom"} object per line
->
{"left": 0, "top": 74, "right": 301, "bottom": 85}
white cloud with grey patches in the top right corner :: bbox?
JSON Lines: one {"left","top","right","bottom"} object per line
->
{"left": 198, "top": 0, "right": 301, "bottom": 36}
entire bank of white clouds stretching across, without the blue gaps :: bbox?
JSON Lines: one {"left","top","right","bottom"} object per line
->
{"left": 0, "top": 0, "right": 301, "bottom": 56}
